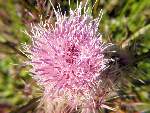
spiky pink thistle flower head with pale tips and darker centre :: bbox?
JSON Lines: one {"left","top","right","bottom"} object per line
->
{"left": 26, "top": 1, "right": 112, "bottom": 113}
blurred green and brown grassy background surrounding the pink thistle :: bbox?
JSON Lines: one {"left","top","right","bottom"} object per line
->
{"left": 0, "top": 0, "right": 150, "bottom": 113}
